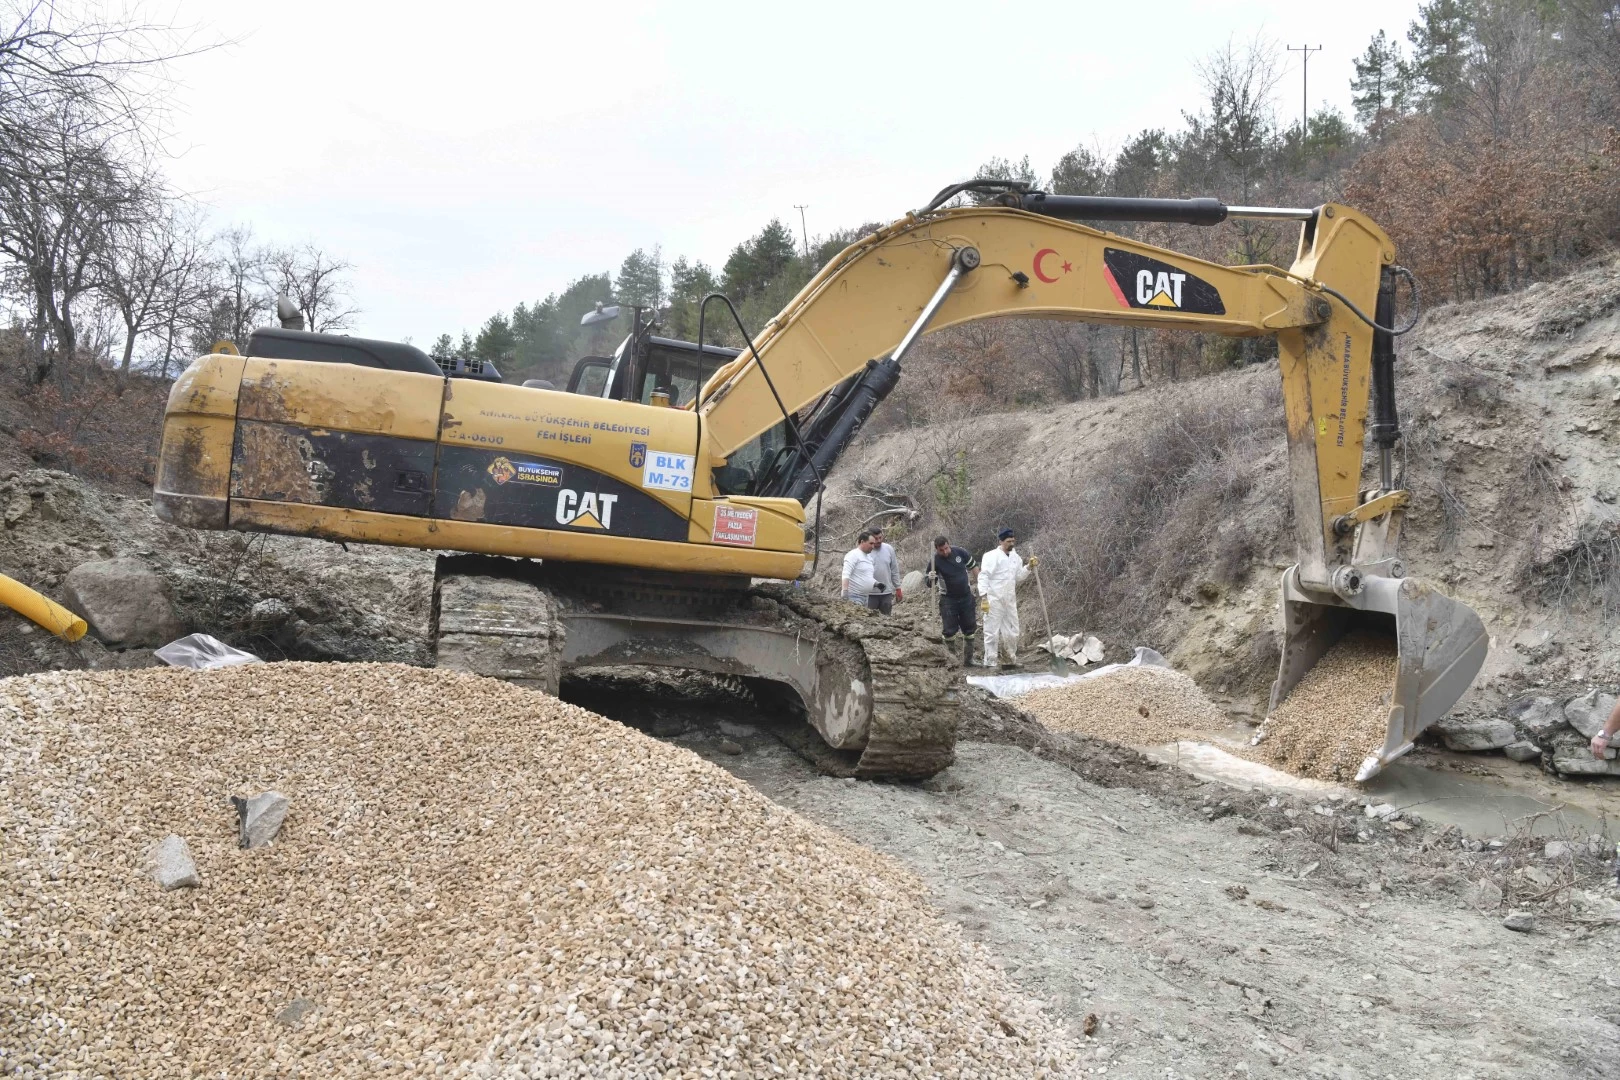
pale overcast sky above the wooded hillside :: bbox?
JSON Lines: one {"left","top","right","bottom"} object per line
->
{"left": 168, "top": 0, "right": 1416, "bottom": 347}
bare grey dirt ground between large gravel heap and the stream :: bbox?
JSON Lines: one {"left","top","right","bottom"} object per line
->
{"left": 564, "top": 680, "right": 1620, "bottom": 1080}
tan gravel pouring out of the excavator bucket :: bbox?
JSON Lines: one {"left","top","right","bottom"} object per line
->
{"left": 1252, "top": 631, "right": 1400, "bottom": 780}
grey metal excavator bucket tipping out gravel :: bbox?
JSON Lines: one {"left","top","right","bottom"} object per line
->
{"left": 1270, "top": 567, "right": 1489, "bottom": 782}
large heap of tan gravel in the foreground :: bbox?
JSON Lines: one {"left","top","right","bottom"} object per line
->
{"left": 9, "top": 664, "right": 1077, "bottom": 1077}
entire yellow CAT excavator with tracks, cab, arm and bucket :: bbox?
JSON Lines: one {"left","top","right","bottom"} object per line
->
{"left": 152, "top": 180, "right": 1486, "bottom": 779}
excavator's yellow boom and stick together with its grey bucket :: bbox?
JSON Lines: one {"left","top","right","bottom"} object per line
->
{"left": 683, "top": 191, "right": 1487, "bottom": 779}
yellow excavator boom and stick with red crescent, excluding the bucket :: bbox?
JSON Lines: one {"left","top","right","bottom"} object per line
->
{"left": 698, "top": 198, "right": 1395, "bottom": 588}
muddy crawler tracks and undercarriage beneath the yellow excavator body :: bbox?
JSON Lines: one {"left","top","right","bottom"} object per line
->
{"left": 433, "top": 555, "right": 961, "bottom": 779}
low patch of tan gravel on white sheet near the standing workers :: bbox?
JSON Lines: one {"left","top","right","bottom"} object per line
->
{"left": 1016, "top": 667, "right": 1228, "bottom": 746}
